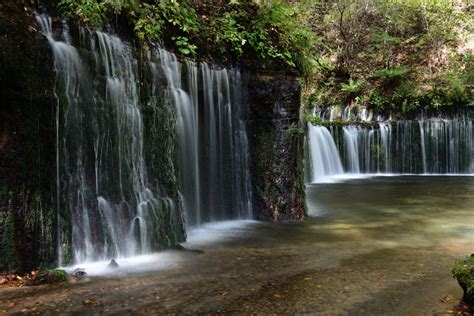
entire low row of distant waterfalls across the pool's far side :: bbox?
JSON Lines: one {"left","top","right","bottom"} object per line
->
{"left": 308, "top": 116, "right": 474, "bottom": 181}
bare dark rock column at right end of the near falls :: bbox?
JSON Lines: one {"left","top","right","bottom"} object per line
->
{"left": 243, "top": 70, "right": 306, "bottom": 221}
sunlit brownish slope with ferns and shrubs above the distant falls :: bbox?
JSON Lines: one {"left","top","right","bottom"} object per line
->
{"left": 305, "top": 0, "right": 474, "bottom": 112}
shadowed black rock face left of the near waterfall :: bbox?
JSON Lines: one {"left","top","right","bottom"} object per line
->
{"left": 0, "top": 0, "right": 56, "bottom": 272}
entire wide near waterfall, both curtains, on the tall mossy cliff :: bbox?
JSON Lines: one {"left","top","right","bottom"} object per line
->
{"left": 37, "top": 15, "right": 252, "bottom": 264}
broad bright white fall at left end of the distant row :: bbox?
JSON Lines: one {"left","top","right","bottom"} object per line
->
{"left": 308, "top": 123, "right": 344, "bottom": 182}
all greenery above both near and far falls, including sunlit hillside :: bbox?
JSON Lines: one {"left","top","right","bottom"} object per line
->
{"left": 54, "top": 0, "right": 474, "bottom": 112}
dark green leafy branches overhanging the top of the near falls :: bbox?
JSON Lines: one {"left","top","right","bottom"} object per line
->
{"left": 60, "top": 0, "right": 314, "bottom": 69}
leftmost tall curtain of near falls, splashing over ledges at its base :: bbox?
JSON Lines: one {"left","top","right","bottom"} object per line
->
{"left": 37, "top": 16, "right": 182, "bottom": 263}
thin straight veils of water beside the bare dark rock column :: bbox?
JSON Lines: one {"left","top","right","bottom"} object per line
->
{"left": 159, "top": 49, "right": 252, "bottom": 226}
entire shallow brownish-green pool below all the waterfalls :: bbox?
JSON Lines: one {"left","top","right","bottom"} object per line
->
{"left": 0, "top": 176, "right": 474, "bottom": 315}
